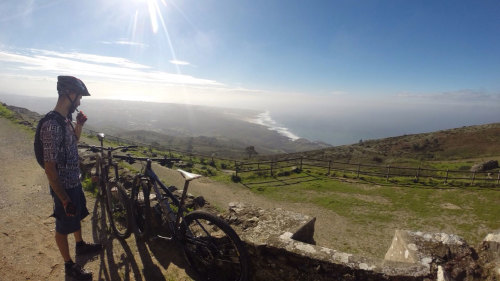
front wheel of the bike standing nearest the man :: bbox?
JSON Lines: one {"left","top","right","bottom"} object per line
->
{"left": 106, "top": 181, "right": 132, "bottom": 239}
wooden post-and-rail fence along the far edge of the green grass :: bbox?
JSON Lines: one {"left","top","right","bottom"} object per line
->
{"left": 236, "top": 157, "right": 500, "bottom": 185}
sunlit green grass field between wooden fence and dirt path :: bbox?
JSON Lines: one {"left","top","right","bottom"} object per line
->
{"left": 238, "top": 166, "right": 500, "bottom": 257}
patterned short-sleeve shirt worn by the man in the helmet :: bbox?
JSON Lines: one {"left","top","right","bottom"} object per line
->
{"left": 40, "top": 113, "right": 81, "bottom": 189}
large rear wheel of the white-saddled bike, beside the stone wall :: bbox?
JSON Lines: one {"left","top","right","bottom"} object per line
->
{"left": 181, "top": 211, "right": 249, "bottom": 281}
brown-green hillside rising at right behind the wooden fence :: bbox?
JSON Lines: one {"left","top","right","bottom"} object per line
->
{"left": 264, "top": 123, "right": 500, "bottom": 164}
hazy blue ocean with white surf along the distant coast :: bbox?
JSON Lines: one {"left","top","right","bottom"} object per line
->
{"left": 245, "top": 105, "right": 500, "bottom": 145}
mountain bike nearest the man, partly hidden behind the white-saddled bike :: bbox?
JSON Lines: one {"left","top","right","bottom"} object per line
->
{"left": 78, "top": 133, "right": 137, "bottom": 239}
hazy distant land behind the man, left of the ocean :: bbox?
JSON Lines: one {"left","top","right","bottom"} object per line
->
{"left": 1, "top": 96, "right": 330, "bottom": 157}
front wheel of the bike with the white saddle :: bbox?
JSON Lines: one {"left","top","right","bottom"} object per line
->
{"left": 130, "top": 176, "right": 151, "bottom": 240}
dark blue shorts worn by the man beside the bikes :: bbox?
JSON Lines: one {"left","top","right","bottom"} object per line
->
{"left": 50, "top": 185, "right": 89, "bottom": 234}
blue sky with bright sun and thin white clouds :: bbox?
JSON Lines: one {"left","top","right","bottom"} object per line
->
{"left": 0, "top": 0, "right": 500, "bottom": 143}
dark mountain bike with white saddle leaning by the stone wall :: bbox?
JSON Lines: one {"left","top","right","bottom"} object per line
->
{"left": 115, "top": 156, "right": 249, "bottom": 281}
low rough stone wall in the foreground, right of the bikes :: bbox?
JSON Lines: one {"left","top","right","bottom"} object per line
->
{"left": 224, "top": 203, "right": 500, "bottom": 281}
